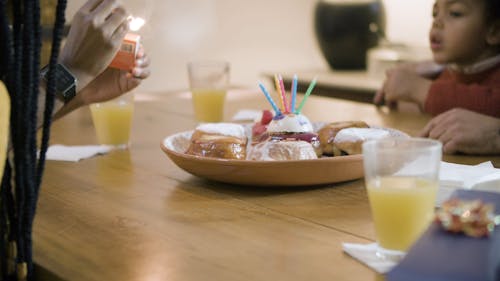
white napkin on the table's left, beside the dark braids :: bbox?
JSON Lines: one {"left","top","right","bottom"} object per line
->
{"left": 45, "top": 144, "right": 113, "bottom": 162}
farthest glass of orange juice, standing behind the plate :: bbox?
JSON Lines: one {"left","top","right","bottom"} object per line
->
{"left": 188, "top": 61, "right": 229, "bottom": 122}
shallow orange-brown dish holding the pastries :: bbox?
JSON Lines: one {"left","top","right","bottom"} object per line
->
{"left": 161, "top": 131, "right": 363, "bottom": 186}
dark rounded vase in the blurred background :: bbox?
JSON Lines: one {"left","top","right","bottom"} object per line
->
{"left": 314, "top": 0, "right": 385, "bottom": 70}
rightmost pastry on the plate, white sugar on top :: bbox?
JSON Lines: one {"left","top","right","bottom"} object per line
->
{"left": 333, "top": 128, "right": 390, "bottom": 155}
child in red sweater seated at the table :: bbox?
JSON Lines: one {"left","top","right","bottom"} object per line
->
{"left": 374, "top": 0, "right": 500, "bottom": 154}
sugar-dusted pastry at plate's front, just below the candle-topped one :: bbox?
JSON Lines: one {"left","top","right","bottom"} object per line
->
{"left": 248, "top": 140, "right": 318, "bottom": 161}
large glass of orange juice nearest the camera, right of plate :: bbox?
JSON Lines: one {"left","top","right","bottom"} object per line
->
{"left": 363, "top": 138, "right": 442, "bottom": 260}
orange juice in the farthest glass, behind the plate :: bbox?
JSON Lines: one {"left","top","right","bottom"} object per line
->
{"left": 191, "top": 89, "right": 226, "bottom": 122}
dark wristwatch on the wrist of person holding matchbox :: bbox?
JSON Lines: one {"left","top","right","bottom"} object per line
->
{"left": 40, "top": 63, "right": 77, "bottom": 103}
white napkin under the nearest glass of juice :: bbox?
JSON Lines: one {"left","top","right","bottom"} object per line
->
{"left": 342, "top": 243, "right": 397, "bottom": 274}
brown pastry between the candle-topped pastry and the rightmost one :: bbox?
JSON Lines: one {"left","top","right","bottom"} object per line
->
{"left": 318, "top": 121, "right": 369, "bottom": 156}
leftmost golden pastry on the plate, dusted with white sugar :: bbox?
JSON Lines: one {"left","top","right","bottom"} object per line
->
{"left": 186, "top": 123, "right": 248, "bottom": 160}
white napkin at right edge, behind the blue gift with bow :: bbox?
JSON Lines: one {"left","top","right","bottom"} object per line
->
{"left": 436, "top": 161, "right": 500, "bottom": 206}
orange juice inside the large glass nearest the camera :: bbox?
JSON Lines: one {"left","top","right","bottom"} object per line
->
{"left": 367, "top": 176, "right": 437, "bottom": 251}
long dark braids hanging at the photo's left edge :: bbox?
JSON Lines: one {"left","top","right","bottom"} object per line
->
{"left": 0, "top": 0, "right": 67, "bottom": 281}
